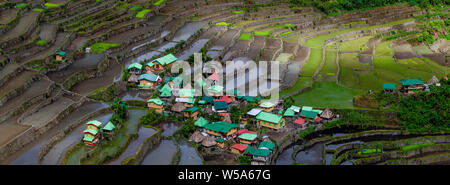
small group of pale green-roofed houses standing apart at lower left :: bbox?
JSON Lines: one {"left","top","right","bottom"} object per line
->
{"left": 83, "top": 120, "right": 116, "bottom": 146}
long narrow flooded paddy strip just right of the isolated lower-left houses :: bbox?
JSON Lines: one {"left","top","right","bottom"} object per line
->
{"left": 109, "top": 127, "right": 156, "bottom": 165}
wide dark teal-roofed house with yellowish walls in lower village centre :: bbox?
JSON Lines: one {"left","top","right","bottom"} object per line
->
{"left": 205, "top": 121, "right": 239, "bottom": 139}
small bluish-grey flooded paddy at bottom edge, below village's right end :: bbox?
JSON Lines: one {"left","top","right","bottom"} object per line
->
{"left": 295, "top": 143, "right": 324, "bottom": 165}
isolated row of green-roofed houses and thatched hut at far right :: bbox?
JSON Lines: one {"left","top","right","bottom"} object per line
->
{"left": 383, "top": 76, "right": 441, "bottom": 94}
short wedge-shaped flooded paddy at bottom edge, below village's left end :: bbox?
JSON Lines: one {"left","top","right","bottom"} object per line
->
{"left": 142, "top": 140, "right": 177, "bottom": 165}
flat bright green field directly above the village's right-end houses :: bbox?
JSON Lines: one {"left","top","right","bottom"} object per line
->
{"left": 292, "top": 81, "right": 365, "bottom": 109}
